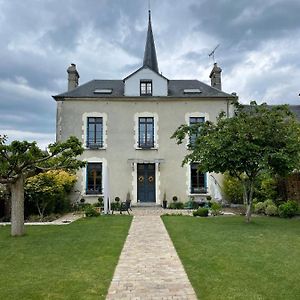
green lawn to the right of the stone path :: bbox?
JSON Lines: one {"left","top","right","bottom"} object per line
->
{"left": 163, "top": 216, "right": 300, "bottom": 300}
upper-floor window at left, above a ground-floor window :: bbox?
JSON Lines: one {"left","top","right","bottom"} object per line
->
{"left": 87, "top": 117, "right": 103, "bottom": 148}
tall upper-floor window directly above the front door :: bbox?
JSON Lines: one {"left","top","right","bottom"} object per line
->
{"left": 139, "top": 117, "right": 154, "bottom": 148}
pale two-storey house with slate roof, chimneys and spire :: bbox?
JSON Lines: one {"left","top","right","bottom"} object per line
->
{"left": 53, "top": 12, "right": 236, "bottom": 205}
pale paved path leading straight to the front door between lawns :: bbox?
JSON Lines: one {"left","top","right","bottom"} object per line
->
{"left": 106, "top": 215, "right": 197, "bottom": 300}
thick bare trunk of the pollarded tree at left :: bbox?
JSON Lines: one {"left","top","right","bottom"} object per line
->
{"left": 11, "top": 176, "right": 25, "bottom": 236}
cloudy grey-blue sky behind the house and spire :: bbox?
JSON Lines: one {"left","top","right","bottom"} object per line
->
{"left": 0, "top": 0, "right": 300, "bottom": 147}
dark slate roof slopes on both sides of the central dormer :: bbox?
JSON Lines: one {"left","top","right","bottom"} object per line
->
{"left": 53, "top": 80, "right": 235, "bottom": 100}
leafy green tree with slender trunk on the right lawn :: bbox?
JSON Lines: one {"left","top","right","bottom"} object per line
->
{"left": 172, "top": 102, "right": 300, "bottom": 222}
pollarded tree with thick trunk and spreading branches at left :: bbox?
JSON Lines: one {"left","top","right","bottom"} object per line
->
{"left": 0, "top": 136, "right": 85, "bottom": 236}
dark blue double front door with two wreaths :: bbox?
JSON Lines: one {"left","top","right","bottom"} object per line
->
{"left": 137, "top": 164, "right": 156, "bottom": 202}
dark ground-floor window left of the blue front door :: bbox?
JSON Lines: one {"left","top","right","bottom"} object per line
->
{"left": 86, "top": 163, "right": 102, "bottom": 194}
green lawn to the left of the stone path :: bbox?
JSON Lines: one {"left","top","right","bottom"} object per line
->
{"left": 0, "top": 216, "right": 131, "bottom": 300}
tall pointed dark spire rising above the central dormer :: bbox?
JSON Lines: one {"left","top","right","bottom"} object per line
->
{"left": 143, "top": 10, "right": 158, "bottom": 73}
